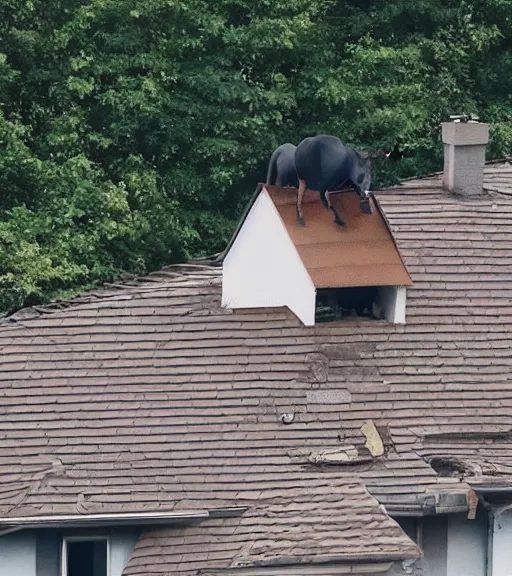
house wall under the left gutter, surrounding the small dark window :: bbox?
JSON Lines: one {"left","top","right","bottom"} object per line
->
{"left": 0, "top": 528, "right": 140, "bottom": 576}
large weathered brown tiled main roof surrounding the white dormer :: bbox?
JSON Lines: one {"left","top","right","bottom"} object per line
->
{"left": 0, "top": 163, "right": 512, "bottom": 574}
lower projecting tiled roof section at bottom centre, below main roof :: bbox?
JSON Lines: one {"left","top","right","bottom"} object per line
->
{"left": 124, "top": 474, "right": 419, "bottom": 576}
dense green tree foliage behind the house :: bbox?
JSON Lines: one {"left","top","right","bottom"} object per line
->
{"left": 0, "top": 0, "right": 512, "bottom": 311}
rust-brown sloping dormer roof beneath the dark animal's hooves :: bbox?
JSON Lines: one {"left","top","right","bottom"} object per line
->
{"left": 226, "top": 185, "right": 412, "bottom": 288}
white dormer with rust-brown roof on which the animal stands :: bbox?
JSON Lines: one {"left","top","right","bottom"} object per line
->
{"left": 222, "top": 185, "right": 412, "bottom": 326}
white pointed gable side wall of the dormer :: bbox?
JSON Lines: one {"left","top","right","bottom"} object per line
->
{"left": 222, "top": 189, "right": 316, "bottom": 326}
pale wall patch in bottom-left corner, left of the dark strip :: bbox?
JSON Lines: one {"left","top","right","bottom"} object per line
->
{"left": 0, "top": 532, "right": 36, "bottom": 576}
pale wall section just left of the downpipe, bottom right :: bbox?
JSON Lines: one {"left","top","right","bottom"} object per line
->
{"left": 447, "top": 514, "right": 486, "bottom": 576}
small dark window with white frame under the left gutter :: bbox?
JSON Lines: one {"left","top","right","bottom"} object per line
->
{"left": 61, "top": 536, "right": 110, "bottom": 576}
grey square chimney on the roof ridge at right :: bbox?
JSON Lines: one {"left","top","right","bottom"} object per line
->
{"left": 442, "top": 120, "right": 489, "bottom": 196}
